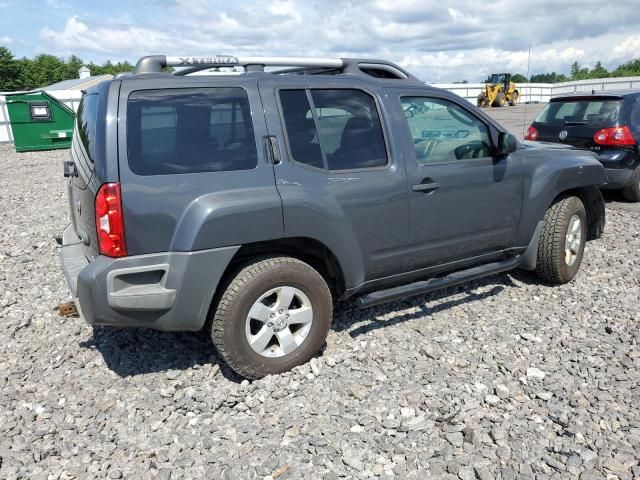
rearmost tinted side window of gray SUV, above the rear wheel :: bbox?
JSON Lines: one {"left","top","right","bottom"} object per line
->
{"left": 127, "top": 88, "right": 258, "bottom": 175}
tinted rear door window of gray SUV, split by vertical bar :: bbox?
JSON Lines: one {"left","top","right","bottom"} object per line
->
{"left": 280, "top": 89, "right": 387, "bottom": 170}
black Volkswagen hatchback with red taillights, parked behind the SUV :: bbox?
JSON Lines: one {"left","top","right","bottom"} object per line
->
{"left": 525, "top": 90, "right": 640, "bottom": 202}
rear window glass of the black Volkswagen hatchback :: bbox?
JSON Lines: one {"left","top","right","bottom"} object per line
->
{"left": 536, "top": 98, "right": 622, "bottom": 126}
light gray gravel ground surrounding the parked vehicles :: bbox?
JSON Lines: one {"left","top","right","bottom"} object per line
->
{"left": 0, "top": 146, "right": 640, "bottom": 480}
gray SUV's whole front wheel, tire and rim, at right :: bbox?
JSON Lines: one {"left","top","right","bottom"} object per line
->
{"left": 536, "top": 197, "right": 587, "bottom": 285}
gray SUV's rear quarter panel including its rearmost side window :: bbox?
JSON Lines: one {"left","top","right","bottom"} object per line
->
{"left": 118, "top": 75, "right": 284, "bottom": 255}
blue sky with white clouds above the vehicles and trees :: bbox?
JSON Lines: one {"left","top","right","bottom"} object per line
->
{"left": 0, "top": 0, "right": 640, "bottom": 83}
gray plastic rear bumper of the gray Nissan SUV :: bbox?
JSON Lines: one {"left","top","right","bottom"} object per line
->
{"left": 60, "top": 225, "right": 240, "bottom": 331}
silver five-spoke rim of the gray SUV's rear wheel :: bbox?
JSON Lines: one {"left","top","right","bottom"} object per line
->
{"left": 245, "top": 286, "right": 313, "bottom": 358}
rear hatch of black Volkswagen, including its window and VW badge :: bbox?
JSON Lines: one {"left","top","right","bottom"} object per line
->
{"left": 533, "top": 95, "right": 622, "bottom": 150}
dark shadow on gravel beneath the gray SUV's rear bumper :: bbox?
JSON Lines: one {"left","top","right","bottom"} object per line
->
{"left": 80, "top": 327, "right": 244, "bottom": 383}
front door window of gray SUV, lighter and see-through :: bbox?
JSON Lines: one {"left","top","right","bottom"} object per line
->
{"left": 402, "top": 97, "right": 491, "bottom": 165}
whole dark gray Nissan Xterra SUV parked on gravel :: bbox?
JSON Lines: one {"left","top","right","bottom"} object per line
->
{"left": 61, "top": 56, "right": 607, "bottom": 378}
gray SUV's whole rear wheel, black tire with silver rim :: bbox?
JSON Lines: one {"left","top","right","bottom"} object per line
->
{"left": 211, "top": 257, "right": 333, "bottom": 379}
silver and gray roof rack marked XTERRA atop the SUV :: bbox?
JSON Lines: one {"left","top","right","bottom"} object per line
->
{"left": 133, "top": 55, "right": 419, "bottom": 81}
